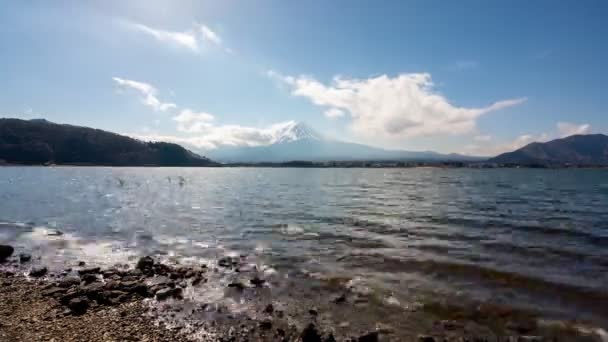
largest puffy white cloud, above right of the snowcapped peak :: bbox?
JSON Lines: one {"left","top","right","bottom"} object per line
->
{"left": 268, "top": 71, "right": 526, "bottom": 140}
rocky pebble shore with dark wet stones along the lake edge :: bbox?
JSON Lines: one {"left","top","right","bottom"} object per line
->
{"left": 0, "top": 245, "right": 605, "bottom": 342}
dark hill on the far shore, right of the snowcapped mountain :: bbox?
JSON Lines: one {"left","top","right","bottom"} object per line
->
{"left": 488, "top": 134, "right": 608, "bottom": 166}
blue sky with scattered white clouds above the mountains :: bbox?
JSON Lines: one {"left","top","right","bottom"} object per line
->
{"left": 0, "top": 0, "right": 608, "bottom": 156}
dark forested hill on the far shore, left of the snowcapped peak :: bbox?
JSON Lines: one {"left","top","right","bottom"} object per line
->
{"left": 0, "top": 119, "right": 216, "bottom": 166}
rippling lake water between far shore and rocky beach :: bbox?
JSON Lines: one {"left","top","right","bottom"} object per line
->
{"left": 0, "top": 167, "right": 608, "bottom": 326}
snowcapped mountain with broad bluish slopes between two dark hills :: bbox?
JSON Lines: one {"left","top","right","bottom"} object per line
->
{"left": 205, "top": 121, "right": 484, "bottom": 163}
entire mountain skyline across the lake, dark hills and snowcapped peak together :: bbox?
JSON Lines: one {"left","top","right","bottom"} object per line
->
{"left": 0, "top": 118, "right": 608, "bottom": 167}
